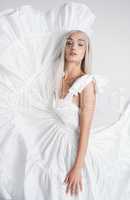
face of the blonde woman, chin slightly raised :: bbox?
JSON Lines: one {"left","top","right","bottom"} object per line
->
{"left": 65, "top": 32, "right": 86, "bottom": 63}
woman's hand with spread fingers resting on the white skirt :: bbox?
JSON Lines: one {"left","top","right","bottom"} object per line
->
{"left": 64, "top": 166, "right": 83, "bottom": 195}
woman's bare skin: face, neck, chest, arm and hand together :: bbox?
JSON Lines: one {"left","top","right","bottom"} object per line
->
{"left": 59, "top": 32, "right": 96, "bottom": 195}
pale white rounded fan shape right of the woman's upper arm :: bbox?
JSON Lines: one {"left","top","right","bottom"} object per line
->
{"left": 92, "top": 74, "right": 130, "bottom": 131}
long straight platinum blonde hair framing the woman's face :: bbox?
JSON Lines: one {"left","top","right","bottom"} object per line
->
{"left": 56, "top": 30, "right": 92, "bottom": 101}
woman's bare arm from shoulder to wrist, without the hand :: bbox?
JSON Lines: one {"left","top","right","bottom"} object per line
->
{"left": 74, "top": 81, "right": 96, "bottom": 169}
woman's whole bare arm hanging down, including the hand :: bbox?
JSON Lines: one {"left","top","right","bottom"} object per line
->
{"left": 64, "top": 81, "right": 96, "bottom": 195}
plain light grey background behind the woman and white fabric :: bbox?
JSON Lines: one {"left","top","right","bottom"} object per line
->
{"left": 0, "top": 0, "right": 130, "bottom": 94}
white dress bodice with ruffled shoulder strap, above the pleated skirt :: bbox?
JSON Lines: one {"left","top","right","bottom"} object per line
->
{"left": 54, "top": 74, "right": 94, "bottom": 129}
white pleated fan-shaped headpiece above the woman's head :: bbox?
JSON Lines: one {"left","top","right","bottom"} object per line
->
{"left": 46, "top": 2, "right": 96, "bottom": 37}
